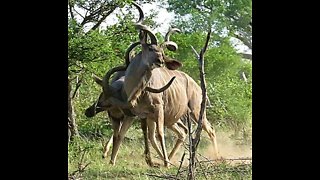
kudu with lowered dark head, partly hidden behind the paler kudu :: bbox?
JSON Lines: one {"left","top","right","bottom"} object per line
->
{"left": 85, "top": 4, "right": 183, "bottom": 166}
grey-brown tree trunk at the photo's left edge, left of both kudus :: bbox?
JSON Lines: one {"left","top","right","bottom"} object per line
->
{"left": 68, "top": 79, "right": 79, "bottom": 142}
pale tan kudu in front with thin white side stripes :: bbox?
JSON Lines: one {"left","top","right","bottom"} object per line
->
{"left": 105, "top": 2, "right": 218, "bottom": 167}
